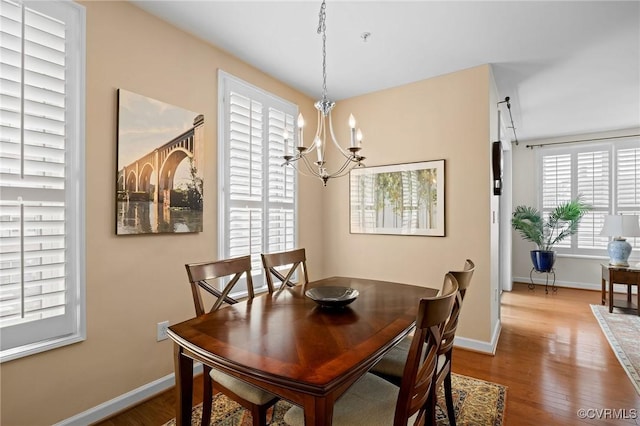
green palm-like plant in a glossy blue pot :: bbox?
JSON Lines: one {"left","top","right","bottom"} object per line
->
{"left": 511, "top": 197, "right": 591, "bottom": 272}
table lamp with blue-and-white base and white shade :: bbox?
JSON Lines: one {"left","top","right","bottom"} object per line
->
{"left": 600, "top": 214, "right": 640, "bottom": 266}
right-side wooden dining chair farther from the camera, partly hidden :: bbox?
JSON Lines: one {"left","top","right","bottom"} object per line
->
{"left": 371, "top": 259, "right": 475, "bottom": 426}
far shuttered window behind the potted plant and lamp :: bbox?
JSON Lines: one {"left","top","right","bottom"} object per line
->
{"left": 538, "top": 138, "right": 640, "bottom": 257}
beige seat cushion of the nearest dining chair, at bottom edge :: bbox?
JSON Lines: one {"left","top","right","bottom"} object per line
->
{"left": 284, "top": 373, "right": 417, "bottom": 426}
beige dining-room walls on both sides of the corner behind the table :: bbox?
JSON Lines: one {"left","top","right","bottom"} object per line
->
{"left": 0, "top": 2, "right": 491, "bottom": 426}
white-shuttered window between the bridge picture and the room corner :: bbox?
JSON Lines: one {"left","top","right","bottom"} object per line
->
{"left": 218, "top": 71, "right": 297, "bottom": 288}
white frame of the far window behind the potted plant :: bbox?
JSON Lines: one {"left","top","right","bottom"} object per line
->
{"left": 536, "top": 136, "right": 640, "bottom": 261}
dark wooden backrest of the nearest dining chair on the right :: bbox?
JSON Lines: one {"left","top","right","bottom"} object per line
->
{"left": 394, "top": 274, "right": 458, "bottom": 425}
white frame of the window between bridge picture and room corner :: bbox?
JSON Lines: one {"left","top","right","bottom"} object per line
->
{"left": 218, "top": 69, "right": 299, "bottom": 297}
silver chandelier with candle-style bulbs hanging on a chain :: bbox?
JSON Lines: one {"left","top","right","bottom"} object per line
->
{"left": 283, "top": 0, "right": 364, "bottom": 186}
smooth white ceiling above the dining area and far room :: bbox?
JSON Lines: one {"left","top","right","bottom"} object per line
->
{"left": 132, "top": 0, "right": 640, "bottom": 141}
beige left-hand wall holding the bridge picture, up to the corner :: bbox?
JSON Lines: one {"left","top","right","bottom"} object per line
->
{"left": 0, "top": 2, "right": 322, "bottom": 426}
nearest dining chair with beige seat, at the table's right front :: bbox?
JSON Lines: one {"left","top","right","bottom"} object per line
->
{"left": 284, "top": 274, "right": 458, "bottom": 426}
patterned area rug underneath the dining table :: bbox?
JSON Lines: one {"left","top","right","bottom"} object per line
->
{"left": 164, "top": 374, "right": 507, "bottom": 426}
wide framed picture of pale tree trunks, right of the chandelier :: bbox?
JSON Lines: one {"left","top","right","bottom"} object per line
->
{"left": 349, "top": 160, "right": 445, "bottom": 237}
